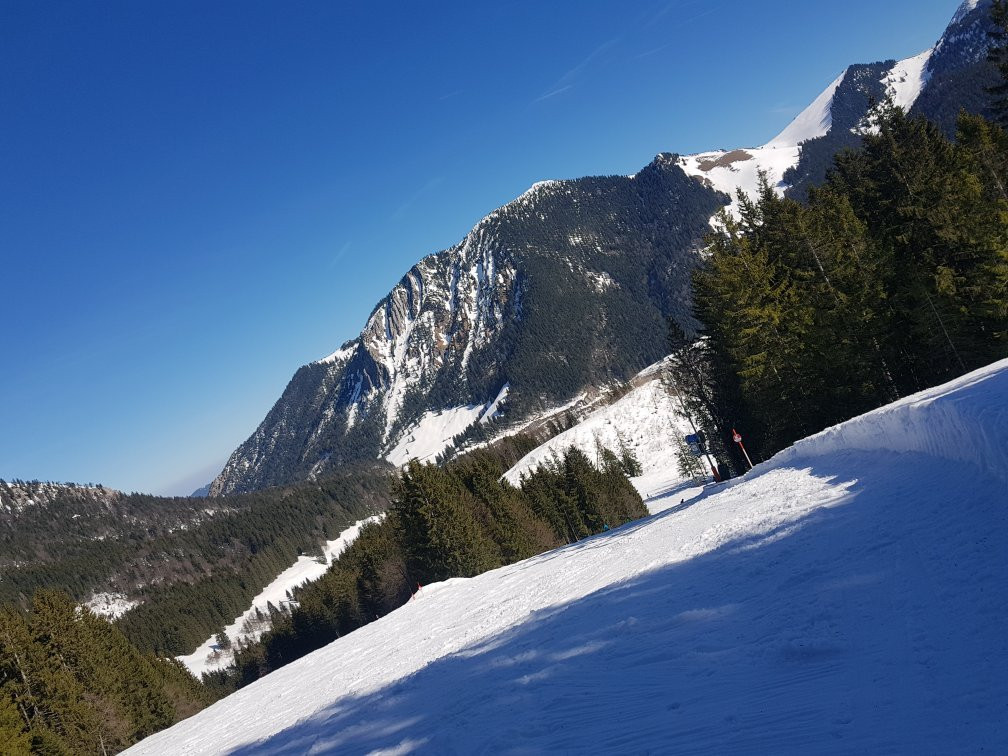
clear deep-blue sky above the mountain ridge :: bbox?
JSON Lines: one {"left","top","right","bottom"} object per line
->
{"left": 0, "top": 0, "right": 957, "bottom": 493}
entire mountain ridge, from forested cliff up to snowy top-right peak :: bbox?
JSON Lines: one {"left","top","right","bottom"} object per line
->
{"left": 210, "top": 0, "right": 992, "bottom": 496}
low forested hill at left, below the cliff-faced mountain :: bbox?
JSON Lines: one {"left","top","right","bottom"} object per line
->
{"left": 0, "top": 465, "right": 391, "bottom": 655}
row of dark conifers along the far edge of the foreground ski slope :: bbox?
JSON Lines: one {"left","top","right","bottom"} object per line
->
{"left": 214, "top": 445, "right": 647, "bottom": 692}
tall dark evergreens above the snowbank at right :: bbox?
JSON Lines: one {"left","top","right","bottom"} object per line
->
{"left": 675, "top": 100, "right": 1008, "bottom": 469}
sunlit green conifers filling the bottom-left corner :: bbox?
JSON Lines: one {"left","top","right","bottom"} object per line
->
{"left": 0, "top": 589, "right": 211, "bottom": 756}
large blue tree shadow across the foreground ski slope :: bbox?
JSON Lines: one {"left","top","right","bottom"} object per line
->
{"left": 233, "top": 454, "right": 1008, "bottom": 756}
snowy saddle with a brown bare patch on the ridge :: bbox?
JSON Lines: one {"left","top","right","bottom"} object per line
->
{"left": 679, "top": 145, "right": 799, "bottom": 217}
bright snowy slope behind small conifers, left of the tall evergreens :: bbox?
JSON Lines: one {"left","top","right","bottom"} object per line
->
{"left": 504, "top": 376, "right": 692, "bottom": 496}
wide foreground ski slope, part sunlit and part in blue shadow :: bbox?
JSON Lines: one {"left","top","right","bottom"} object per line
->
{"left": 133, "top": 361, "right": 1008, "bottom": 756}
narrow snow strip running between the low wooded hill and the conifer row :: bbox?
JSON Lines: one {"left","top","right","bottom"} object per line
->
{"left": 177, "top": 515, "right": 384, "bottom": 677}
